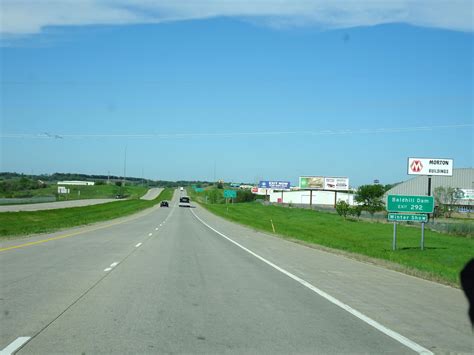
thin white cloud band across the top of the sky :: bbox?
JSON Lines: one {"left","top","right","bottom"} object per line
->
{"left": 0, "top": 0, "right": 474, "bottom": 35}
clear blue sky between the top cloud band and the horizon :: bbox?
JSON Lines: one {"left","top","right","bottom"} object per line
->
{"left": 0, "top": 1, "right": 474, "bottom": 186}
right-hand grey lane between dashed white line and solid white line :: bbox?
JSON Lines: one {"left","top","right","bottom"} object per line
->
{"left": 14, "top": 202, "right": 411, "bottom": 354}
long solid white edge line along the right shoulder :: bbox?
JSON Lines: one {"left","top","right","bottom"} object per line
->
{"left": 191, "top": 210, "right": 433, "bottom": 355}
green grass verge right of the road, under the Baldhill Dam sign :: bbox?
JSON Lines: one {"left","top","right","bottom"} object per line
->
{"left": 203, "top": 203, "right": 474, "bottom": 286}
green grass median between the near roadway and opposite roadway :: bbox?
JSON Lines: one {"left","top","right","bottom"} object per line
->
{"left": 0, "top": 188, "right": 174, "bottom": 237}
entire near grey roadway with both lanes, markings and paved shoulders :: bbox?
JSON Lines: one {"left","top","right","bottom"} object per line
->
{"left": 0, "top": 191, "right": 472, "bottom": 354}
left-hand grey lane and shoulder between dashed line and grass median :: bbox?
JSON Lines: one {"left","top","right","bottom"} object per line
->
{"left": 0, "top": 192, "right": 176, "bottom": 349}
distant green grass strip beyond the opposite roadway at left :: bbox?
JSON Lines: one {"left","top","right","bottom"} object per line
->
{"left": 0, "top": 185, "right": 148, "bottom": 201}
